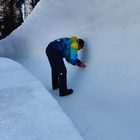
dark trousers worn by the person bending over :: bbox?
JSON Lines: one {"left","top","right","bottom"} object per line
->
{"left": 46, "top": 45, "right": 67, "bottom": 94}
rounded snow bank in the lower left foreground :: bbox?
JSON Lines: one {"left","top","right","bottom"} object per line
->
{"left": 0, "top": 57, "right": 83, "bottom": 140}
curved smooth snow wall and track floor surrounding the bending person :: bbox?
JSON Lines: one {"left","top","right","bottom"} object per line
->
{"left": 0, "top": 0, "right": 140, "bottom": 140}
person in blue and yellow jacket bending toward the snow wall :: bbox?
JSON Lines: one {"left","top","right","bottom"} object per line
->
{"left": 46, "top": 36, "right": 86, "bottom": 96}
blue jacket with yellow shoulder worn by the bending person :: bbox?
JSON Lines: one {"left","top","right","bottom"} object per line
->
{"left": 50, "top": 37, "right": 81, "bottom": 65}
